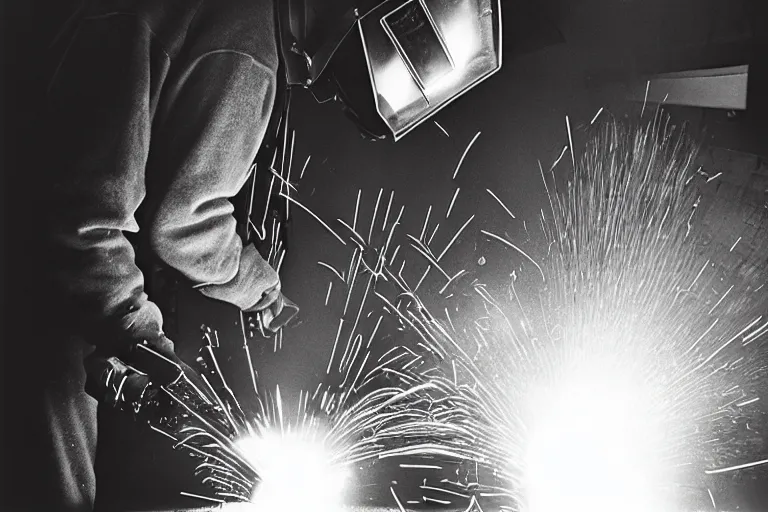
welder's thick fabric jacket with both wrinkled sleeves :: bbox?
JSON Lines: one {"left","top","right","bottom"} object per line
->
{"left": 45, "top": 0, "right": 279, "bottom": 343}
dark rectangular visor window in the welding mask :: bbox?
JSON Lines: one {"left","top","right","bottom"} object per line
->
{"left": 382, "top": 0, "right": 453, "bottom": 89}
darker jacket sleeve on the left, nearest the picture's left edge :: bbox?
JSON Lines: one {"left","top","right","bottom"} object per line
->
{"left": 41, "top": 15, "right": 167, "bottom": 344}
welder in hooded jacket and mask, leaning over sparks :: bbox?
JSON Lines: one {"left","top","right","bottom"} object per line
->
{"left": 4, "top": 0, "right": 501, "bottom": 510}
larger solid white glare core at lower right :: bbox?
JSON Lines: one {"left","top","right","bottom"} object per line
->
{"left": 525, "top": 364, "right": 672, "bottom": 512}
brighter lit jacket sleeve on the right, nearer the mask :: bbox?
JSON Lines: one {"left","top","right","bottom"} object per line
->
{"left": 148, "top": 50, "right": 279, "bottom": 310}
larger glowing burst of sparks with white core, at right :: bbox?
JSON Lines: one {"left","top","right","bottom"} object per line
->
{"left": 332, "top": 114, "right": 768, "bottom": 512}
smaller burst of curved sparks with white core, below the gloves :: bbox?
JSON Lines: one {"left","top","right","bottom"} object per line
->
{"left": 147, "top": 332, "right": 464, "bottom": 512}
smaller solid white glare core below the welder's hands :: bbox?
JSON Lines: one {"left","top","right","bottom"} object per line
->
{"left": 232, "top": 432, "right": 348, "bottom": 512}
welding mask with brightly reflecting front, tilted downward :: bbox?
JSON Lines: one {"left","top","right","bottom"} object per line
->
{"left": 277, "top": 0, "right": 501, "bottom": 140}
